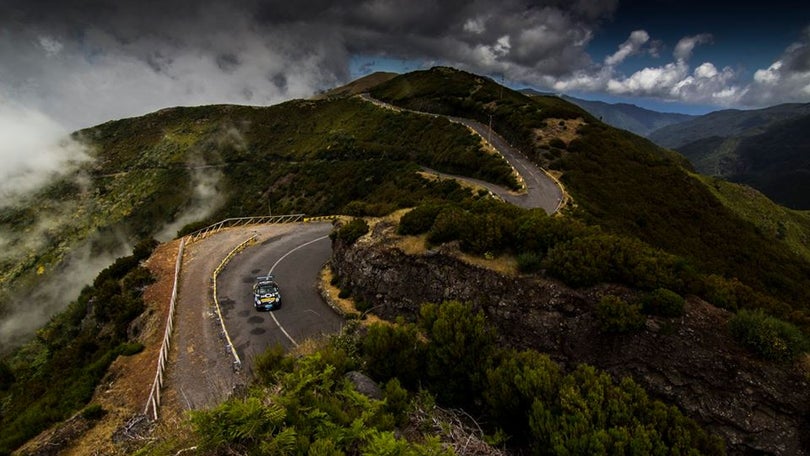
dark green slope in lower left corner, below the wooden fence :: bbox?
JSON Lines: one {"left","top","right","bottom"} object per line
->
{"left": 0, "top": 242, "right": 156, "bottom": 455}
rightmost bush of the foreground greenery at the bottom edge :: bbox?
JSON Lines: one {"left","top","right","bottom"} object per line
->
{"left": 528, "top": 365, "right": 725, "bottom": 455}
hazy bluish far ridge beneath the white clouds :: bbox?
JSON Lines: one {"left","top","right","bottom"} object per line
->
{"left": 521, "top": 89, "right": 695, "bottom": 136}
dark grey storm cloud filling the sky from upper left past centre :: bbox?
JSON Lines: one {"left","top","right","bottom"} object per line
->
{"left": 0, "top": 0, "right": 616, "bottom": 128}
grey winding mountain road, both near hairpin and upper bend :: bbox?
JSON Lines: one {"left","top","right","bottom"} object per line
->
{"left": 158, "top": 95, "right": 563, "bottom": 416}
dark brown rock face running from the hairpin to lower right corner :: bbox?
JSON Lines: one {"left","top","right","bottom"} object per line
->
{"left": 332, "top": 230, "right": 810, "bottom": 455}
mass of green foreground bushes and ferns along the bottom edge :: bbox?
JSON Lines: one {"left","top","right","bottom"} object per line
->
{"left": 139, "top": 301, "right": 725, "bottom": 455}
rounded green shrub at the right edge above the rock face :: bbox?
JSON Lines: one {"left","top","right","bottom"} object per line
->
{"left": 728, "top": 310, "right": 810, "bottom": 362}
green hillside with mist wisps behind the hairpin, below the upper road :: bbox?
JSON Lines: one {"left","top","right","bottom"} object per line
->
{"left": 0, "top": 92, "right": 516, "bottom": 348}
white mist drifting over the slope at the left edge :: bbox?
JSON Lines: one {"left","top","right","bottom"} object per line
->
{"left": 0, "top": 116, "right": 243, "bottom": 354}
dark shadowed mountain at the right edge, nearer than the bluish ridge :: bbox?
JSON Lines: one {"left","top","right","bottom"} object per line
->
{"left": 649, "top": 103, "right": 810, "bottom": 209}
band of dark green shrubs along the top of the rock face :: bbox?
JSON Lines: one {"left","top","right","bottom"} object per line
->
{"left": 398, "top": 198, "right": 810, "bottom": 361}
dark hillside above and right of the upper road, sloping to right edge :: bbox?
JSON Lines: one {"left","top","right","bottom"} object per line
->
{"left": 372, "top": 68, "right": 810, "bottom": 327}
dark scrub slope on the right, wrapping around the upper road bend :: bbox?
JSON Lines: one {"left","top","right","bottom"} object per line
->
{"left": 372, "top": 68, "right": 810, "bottom": 352}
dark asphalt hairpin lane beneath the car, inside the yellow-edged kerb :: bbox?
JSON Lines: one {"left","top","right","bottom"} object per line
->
{"left": 217, "top": 223, "right": 343, "bottom": 376}
